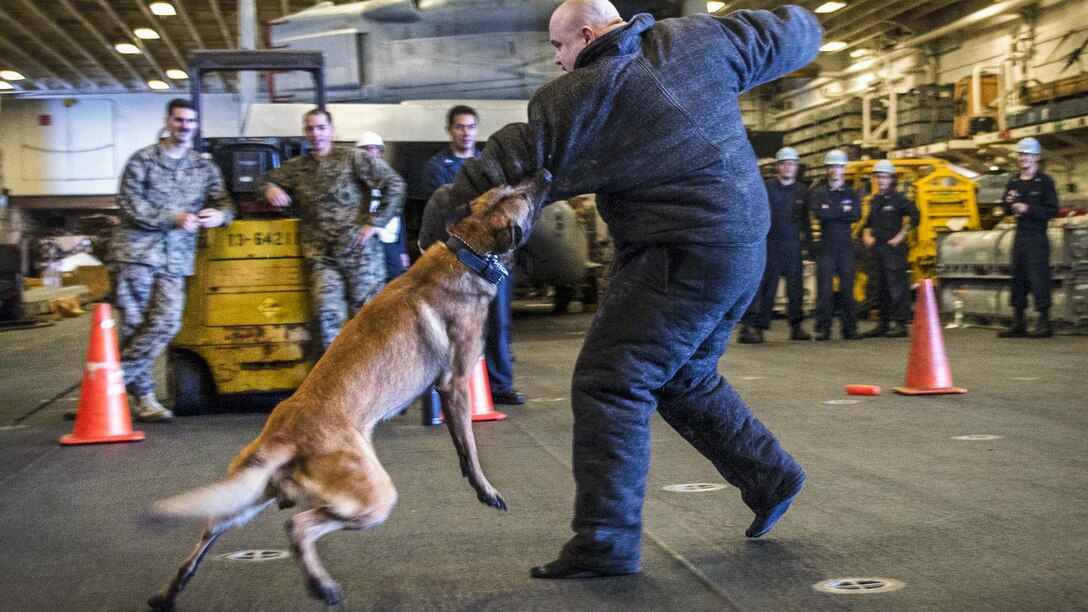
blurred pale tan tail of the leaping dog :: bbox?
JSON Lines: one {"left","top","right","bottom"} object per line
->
{"left": 151, "top": 439, "right": 295, "bottom": 518}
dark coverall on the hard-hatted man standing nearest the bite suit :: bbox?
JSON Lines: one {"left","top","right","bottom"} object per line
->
{"left": 741, "top": 179, "right": 812, "bottom": 329}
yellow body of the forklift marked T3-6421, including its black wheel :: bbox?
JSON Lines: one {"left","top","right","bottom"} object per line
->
{"left": 168, "top": 219, "right": 313, "bottom": 414}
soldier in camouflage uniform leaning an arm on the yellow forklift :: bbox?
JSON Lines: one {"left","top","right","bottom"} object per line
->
{"left": 258, "top": 110, "right": 405, "bottom": 348}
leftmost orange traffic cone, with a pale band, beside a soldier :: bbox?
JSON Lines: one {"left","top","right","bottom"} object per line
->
{"left": 61, "top": 304, "right": 144, "bottom": 444}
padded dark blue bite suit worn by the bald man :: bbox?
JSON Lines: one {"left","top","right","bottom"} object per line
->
{"left": 440, "top": 7, "right": 823, "bottom": 574}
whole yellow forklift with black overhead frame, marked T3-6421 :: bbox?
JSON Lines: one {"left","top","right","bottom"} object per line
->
{"left": 166, "top": 51, "right": 325, "bottom": 415}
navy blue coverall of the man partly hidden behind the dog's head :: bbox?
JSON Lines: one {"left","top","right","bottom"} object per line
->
{"left": 420, "top": 146, "right": 517, "bottom": 393}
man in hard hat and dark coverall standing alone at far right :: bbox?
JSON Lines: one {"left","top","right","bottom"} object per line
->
{"left": 998, "top": 138, "right": 1058, "bottom": 338}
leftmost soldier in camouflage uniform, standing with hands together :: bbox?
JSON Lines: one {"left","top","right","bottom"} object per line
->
{"left": 106, "top": 99, "right": 234, "bottom": 421}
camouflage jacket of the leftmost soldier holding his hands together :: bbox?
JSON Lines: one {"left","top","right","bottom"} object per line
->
{"left": 106, "top": 144, "right": 234, "bottom": 277}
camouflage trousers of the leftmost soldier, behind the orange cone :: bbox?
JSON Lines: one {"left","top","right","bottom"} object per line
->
{"left": 110, "top": 262, "right": 185, "bottom": 395}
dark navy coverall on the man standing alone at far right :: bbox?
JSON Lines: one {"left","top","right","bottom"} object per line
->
{"left": 1004, "top": 172, "right": 1058, "bottom": 314}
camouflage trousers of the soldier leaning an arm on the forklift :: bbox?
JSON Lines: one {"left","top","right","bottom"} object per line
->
{"left": 310, "top": 237, "right": 385, "bottom": 348}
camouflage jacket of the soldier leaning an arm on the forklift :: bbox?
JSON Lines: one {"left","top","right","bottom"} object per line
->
{"left": 257, "top": 148, "right": 406, "bottom": 259}
